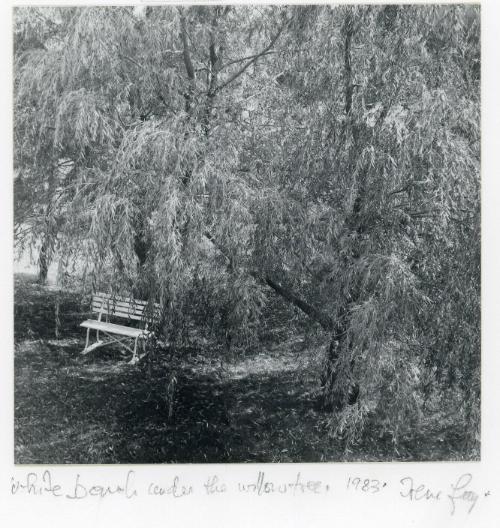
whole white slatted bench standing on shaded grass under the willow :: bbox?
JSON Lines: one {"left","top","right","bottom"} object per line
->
{"left": 80, "top": 293, "right": 160, "bottom": 364}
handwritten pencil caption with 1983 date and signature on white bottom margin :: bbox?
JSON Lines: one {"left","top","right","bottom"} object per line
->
{"left": 10, "top": 469, "right": 491, "bottom": 515}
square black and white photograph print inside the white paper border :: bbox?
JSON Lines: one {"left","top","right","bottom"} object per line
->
{"left": 10, "top": 3, "right": 482, "bottom": 465}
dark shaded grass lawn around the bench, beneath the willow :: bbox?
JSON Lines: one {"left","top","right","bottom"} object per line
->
{"left": 14, "top": 276, "right": 470, "bottom": 464}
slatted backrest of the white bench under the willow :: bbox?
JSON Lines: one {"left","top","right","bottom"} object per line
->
{"left": 92, "top": 293, "right": 160, "bottom": 323}
